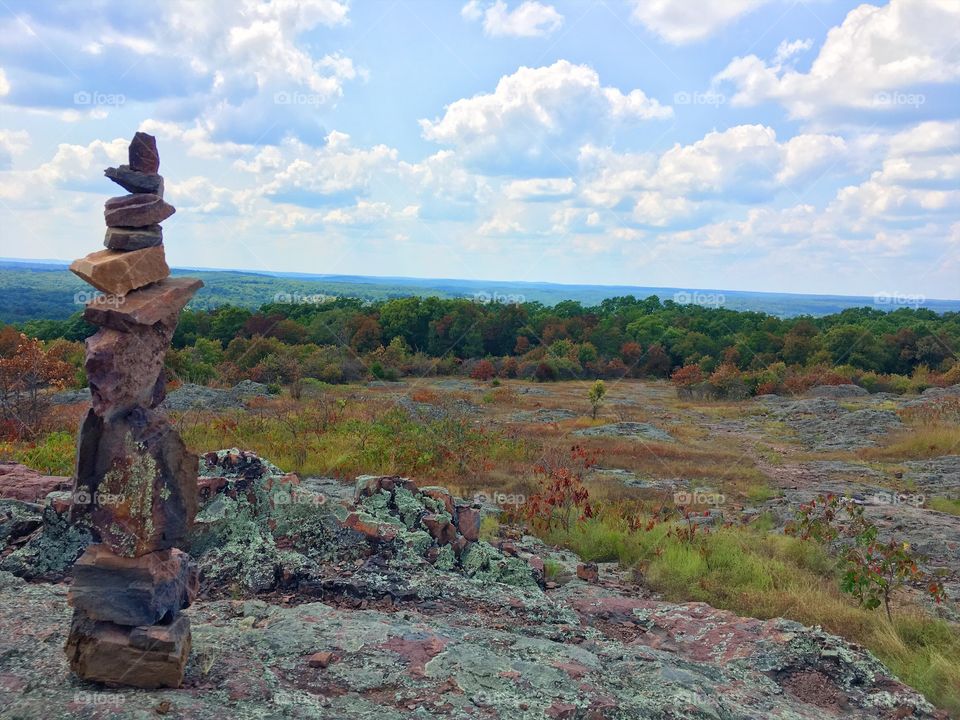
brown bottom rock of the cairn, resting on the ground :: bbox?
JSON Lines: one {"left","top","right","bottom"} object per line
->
{"left": 65, "top": 612, "right": 191, "bottom": 689}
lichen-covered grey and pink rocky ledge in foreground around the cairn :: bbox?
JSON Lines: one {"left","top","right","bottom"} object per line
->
{"left": 0, "top": 450, "right": 945, "bottom": 720}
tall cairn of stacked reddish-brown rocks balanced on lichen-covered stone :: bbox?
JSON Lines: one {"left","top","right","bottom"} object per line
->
{"left": 66, "top": 132, "right": 203, "bottom": 688}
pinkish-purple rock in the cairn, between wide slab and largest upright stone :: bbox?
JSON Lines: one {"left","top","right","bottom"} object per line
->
{"left": 84, "top": 324, "right": 173, "bottom": 417}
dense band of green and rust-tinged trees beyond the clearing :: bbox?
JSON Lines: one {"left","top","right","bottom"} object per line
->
{"left": 13, "top": 296, "right": 960, "bottom": 397}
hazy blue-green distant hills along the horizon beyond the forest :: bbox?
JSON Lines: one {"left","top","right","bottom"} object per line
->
{"left": 0, "top": 259, "right": 960, "bottom": 323}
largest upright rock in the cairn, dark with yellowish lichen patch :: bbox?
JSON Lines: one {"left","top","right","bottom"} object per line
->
{"left": 71, "top": 407, "right": 198, "bottom": 557}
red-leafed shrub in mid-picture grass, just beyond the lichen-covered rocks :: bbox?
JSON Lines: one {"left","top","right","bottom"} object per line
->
{"left": 523, "top": 445, "right": 597, "bottom": 532}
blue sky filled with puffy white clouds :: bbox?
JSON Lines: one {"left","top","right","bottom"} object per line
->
{"left": 0, "top": 0, "right": 960, "bottom": 298}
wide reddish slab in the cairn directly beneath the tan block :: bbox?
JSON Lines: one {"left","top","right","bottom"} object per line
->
{"left": 83, "top": 278, "right": 203, "bottom": 332}
